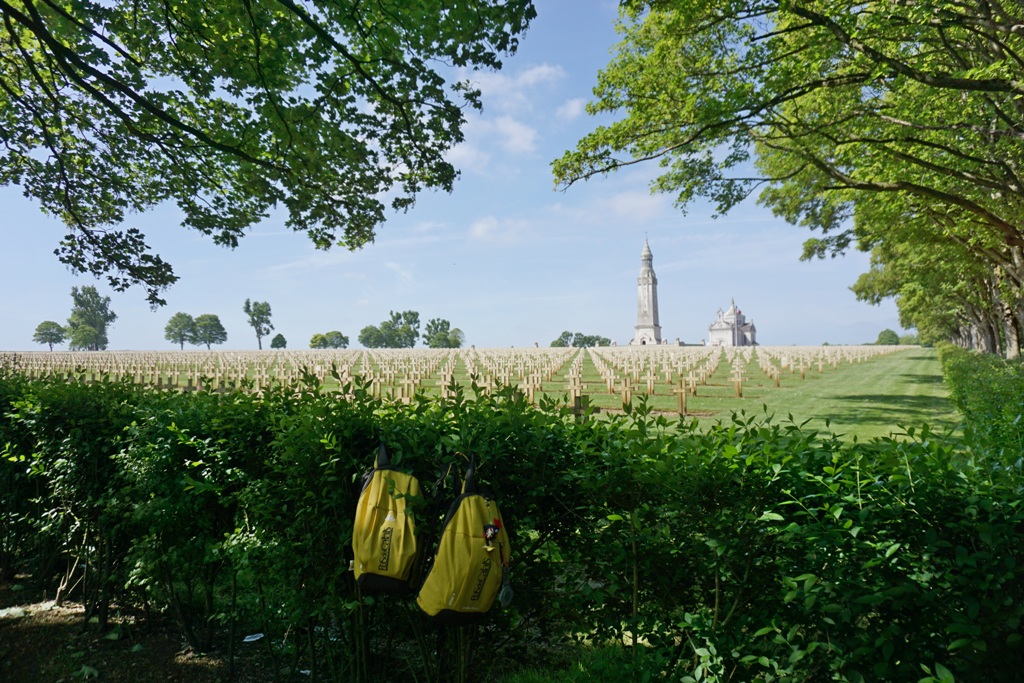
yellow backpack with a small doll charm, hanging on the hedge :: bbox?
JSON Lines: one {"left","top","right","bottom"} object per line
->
{"left": 416, "top": 460, "right": 512, "bottom": 625}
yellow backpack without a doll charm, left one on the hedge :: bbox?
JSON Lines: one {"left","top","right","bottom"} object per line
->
{"left": 352, "top": 443, "right": 421, "bottom": 593}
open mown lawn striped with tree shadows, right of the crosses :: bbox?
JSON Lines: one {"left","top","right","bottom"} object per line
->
{"left": 690, "top": 348, "right": 958, "bottom": 440}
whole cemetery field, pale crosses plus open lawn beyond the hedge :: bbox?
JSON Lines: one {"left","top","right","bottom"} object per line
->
{"left": 0, "top": 346, "right": 957, "bottom": 439}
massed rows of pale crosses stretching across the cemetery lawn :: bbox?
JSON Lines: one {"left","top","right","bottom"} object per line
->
{"left": 0, "top": 345, "right": 913, "bottom": 405}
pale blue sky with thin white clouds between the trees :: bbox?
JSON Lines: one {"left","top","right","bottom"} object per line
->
{"left": 0, "top": 0, "right": 900, "bottom": 350}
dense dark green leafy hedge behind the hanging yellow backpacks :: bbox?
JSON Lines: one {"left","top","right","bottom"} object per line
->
{"left": 0, "top": 376, "right": 1024, "bottom": 681}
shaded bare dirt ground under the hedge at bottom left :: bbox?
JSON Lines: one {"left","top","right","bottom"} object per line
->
{"left": 0, "top": 580, "right": 272, "bottom": 683}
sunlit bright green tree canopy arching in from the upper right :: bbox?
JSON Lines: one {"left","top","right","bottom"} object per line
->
{"left": 554, "top": 0, "right": 1024, "bottom": 355}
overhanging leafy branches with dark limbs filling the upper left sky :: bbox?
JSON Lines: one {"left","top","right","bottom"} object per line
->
{"left": 0, "top": 0, "right": 536, "bottom": 303}
